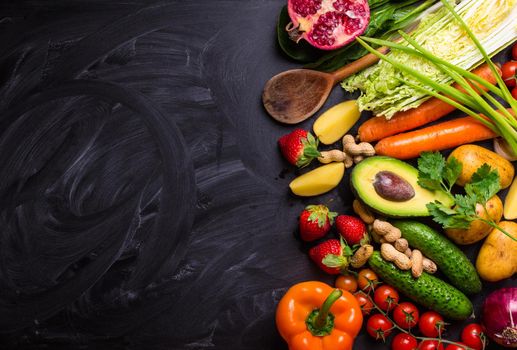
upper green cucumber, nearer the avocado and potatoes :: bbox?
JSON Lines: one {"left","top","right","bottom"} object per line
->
{"left": 392, "top": 220, "right": 482, "bottom": 294}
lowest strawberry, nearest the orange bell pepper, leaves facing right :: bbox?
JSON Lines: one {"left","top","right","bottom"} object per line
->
{"left": 309, "top": 239, "right": 353, "bottom": 275}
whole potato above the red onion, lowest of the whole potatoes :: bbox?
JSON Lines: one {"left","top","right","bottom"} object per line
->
{"left": 476, "top": 221, "right": 517, "bottom": 282}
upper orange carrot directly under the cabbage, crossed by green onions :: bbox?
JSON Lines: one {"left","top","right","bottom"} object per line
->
{"left": 358, "top": 64, "right": 496, "bottom": 142}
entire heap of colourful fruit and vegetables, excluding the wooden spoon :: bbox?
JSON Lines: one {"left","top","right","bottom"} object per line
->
{"left": 264, "top": 0, "right": 517, "bottom": 350}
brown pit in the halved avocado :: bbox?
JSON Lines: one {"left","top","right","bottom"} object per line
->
{"left": 373, "top": 170, "right": 415, "bottom": 202}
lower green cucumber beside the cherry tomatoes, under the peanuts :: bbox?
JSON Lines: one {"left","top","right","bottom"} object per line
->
{"left": 368, "top": 251, "right": 473, "bottom": 320}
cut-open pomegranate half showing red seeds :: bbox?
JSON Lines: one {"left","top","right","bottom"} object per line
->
{"left": 286, "top": 0, "right": 370, "bottom": 50}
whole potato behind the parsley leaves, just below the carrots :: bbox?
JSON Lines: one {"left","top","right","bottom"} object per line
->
{"left": 449, "top": 145, "right": 515, "bottom": 188}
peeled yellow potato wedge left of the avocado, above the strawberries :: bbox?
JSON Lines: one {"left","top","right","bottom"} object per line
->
{"left": 289, "top": 162, "right": 345, "bottom": 197}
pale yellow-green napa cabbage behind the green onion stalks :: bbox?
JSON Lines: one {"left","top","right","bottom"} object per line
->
{"left": 342, "top": 0, "right": 517, "bottom": 119}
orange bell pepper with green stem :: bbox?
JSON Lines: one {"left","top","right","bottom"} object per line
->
{"left": 276, "top": 281, "right": 363, "bottom": 350}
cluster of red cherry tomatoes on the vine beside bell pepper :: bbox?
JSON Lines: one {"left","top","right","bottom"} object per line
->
{"left": 336, "top": 269, "right": 486, "bottom": 350}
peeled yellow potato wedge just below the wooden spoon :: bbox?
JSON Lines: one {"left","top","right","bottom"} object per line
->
{"left": 312, "top": 100, "right": 361, "bottom": 145}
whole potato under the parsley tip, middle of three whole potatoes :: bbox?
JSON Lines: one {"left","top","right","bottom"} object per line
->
{"left": 445, "top": 195, "right": 503, "bottom": 244}
